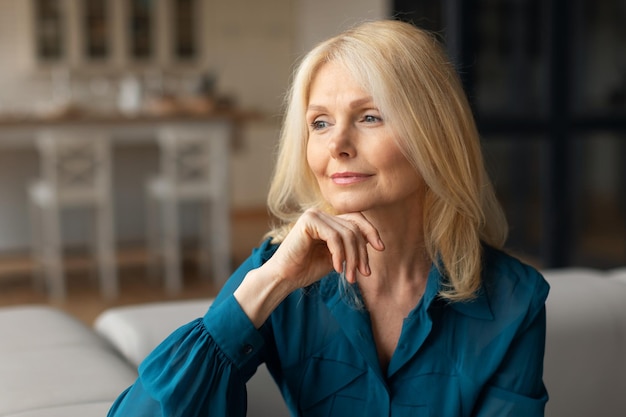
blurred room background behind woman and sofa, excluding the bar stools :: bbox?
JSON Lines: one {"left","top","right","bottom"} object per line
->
{"left": 0, "top": 0, "right": 626, "bottom": 320}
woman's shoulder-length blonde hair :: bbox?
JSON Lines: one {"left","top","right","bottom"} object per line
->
{"left": 268, "top": 20, "right": 508, "bottom": 301}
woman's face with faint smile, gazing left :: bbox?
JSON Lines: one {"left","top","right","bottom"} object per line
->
{"left": 306, "top": 62, "right": 424, "bottom": 213}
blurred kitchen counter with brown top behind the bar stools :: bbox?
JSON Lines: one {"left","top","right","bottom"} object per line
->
{"left": 0, "top": 104, "right": 270, "bottom": 252}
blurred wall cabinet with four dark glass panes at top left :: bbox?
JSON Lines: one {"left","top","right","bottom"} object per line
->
{"left": 30, "top": 0, "right": 203, "bottom": 71}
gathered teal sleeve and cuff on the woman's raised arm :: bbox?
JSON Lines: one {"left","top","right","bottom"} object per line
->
{"left": 108, "top": 242, "right": 276, "bottom": 417}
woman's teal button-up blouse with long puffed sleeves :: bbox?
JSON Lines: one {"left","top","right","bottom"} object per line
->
{"left": 109, "top": 242, "right": 549, "bottom": 417}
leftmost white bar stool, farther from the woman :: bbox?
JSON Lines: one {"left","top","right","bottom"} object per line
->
{"left": 28, "top": 129, "right": 118, "bottom": 299}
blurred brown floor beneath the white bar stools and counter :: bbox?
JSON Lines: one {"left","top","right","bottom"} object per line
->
{"left": 0, "top": 210, "right": 269, "bottom": 324}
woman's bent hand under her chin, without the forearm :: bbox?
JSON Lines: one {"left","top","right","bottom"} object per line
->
{"left": 264, "top": 210, "right": 384, "bottom": 288}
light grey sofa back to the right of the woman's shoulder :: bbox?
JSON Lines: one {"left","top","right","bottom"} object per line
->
{"left": 543, "top": 268, "right": 626, "bottom": 417}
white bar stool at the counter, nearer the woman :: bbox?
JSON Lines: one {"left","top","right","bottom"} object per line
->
{"left": 146, "top": 123, "right": 231, "bottom": 294}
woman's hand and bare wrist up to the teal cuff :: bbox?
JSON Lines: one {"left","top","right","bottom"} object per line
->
{"left": 233, "top": 210, "right": 384, "bottom": 328}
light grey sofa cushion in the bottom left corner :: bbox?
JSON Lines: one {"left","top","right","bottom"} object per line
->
{"left": 0, "top": 306, "right": 137, "bottom": 416}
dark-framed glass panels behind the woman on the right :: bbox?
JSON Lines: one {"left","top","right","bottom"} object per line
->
{"left": 394, "top": 0, "right": 626, "bottom": 268}
